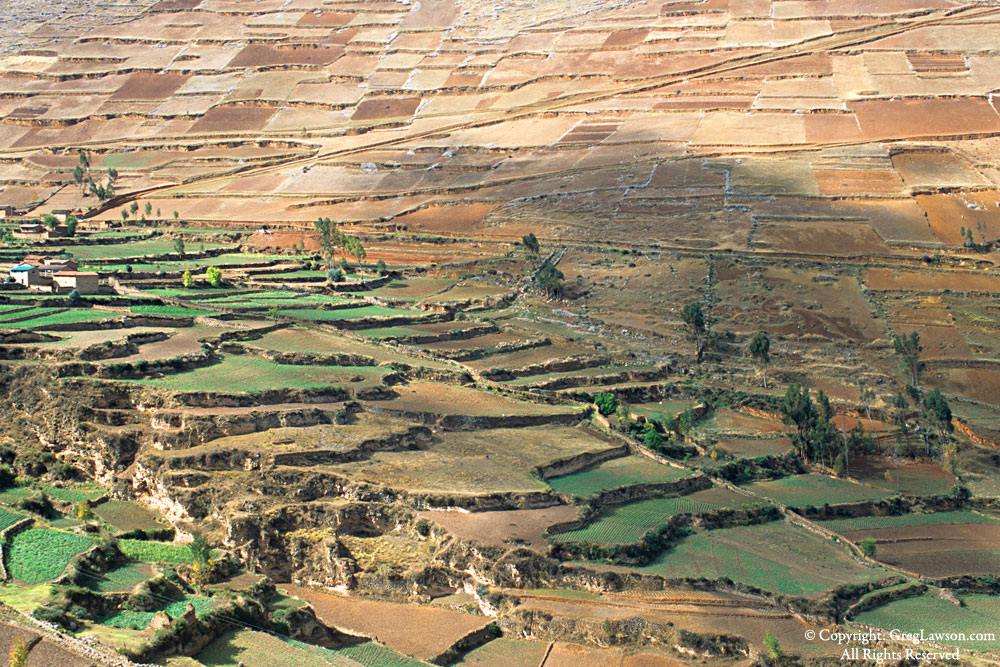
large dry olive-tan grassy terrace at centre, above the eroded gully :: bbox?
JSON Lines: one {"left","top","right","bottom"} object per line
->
{"left": 329, "top": 426, "right": 612, "bottom": 495}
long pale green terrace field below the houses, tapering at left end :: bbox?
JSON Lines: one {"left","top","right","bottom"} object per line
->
{"left": 128, "top": 355, "right": 389, "bottom": 391}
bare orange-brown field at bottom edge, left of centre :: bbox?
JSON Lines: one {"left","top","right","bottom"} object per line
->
{"left": 281, "top": 585, "right": 491, "bottom": 660}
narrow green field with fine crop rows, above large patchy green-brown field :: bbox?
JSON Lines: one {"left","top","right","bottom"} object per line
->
{"left": 552, "top": 489, "right": 753, "bottom": 544}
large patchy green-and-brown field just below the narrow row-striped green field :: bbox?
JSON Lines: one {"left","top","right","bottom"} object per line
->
{"left": 639, "top": 521, "right": 886, "bottom": 595}
